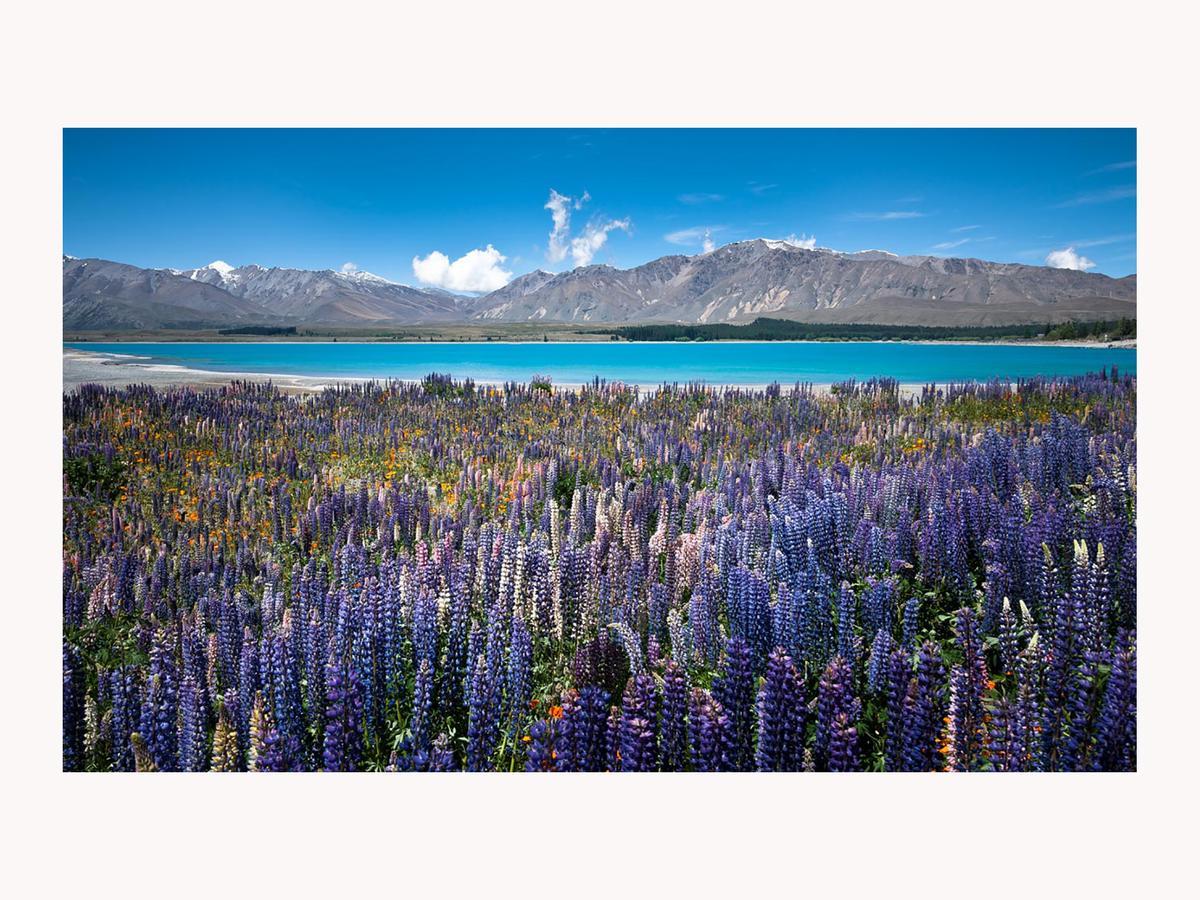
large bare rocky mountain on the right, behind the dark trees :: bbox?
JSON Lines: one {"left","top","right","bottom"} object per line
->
{"left": 473, "top": 240, "right": 1138, "bottom": 325}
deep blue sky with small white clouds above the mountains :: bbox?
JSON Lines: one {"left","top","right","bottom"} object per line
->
{"left": 64, "top": 128, "right": 1138, "bottom": 290}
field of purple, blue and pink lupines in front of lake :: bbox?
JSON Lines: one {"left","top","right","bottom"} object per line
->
{"left": 62, "top": 371, "right": 1136, "bottom": 772}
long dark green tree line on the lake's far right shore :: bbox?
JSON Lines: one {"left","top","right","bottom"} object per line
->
{"left": 595, "top": 318, "right": 1138, "bottom": 341}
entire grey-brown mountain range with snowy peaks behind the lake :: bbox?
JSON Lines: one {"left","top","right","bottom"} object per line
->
{"left": 62, "top": 239, "right": 1138, "bottom": 330}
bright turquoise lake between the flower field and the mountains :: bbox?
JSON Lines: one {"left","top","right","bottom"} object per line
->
{"left": 65, "top": 341, "right": 1138, "bottom": 385}
